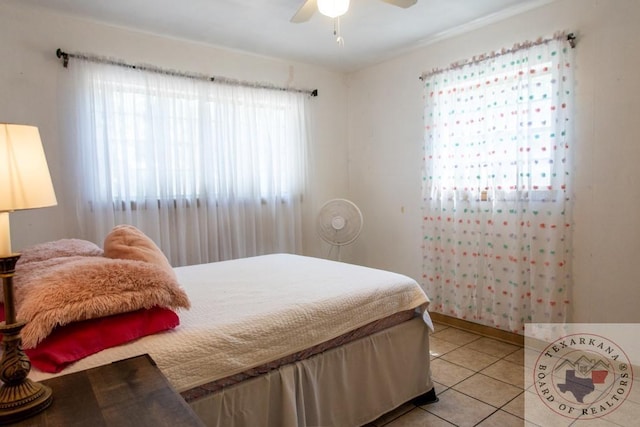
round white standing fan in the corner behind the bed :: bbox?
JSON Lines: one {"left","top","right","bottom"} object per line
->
{"left": 318, "top": 199, "right": 362, "bottom": 260}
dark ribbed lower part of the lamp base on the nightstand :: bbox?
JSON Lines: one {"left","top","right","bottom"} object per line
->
{"left": 0, "top": 322, "right": 53, "bottom": 424}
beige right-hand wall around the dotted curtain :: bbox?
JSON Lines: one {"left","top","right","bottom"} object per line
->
{"left": 348, "top": 0, "right": 640, "bottom": 322}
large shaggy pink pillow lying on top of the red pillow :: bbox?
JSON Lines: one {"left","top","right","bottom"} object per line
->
{"left": 15, "top": 257, "right": 191, "bottom": 348}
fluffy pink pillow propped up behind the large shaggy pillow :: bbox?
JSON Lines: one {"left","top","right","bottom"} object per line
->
{"left": 104, "top": 224, "right": 175, "bottom": 277}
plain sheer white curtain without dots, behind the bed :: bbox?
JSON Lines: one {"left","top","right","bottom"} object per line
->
{"left": 62, "top": 59, "right": 308, "bottom": 266}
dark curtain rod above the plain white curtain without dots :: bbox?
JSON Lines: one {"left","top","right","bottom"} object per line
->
{"left": 56, "top": 48, "right": 318, "bottom": 96}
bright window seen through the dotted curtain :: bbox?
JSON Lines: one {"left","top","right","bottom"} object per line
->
{"left": 427, "top": 50, "right": 566, "bottom": 201}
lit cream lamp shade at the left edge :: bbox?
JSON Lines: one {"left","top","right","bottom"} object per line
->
{"left": 0, "top": 124, "right": 57, "bottom": 212}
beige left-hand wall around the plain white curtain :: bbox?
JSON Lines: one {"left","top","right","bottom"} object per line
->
{"left": 0, "top": 3, "right": 347, "bottom": 256}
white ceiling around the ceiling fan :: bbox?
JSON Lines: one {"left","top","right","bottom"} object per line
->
{"left": 16, "top": 0, "right": 554, "bottom": 71}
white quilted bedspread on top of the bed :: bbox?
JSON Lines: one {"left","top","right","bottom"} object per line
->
{"left": 30, "top": 254, "right": 428, "bottom": 391}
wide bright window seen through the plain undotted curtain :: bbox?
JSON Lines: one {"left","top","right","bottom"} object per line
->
{"left": 92, "top": 78, "right": 304, "bottom": 202}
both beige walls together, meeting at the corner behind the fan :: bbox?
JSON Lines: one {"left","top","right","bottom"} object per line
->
{"left": 0, "top": 0, "right": 640, "bottom": 322}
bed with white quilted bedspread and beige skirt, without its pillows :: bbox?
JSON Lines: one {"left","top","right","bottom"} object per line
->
{"left": 13, "top": 231, "right": 435, "bottom": 426}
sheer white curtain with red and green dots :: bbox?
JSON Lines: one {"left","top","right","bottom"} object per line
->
{"left": 423, "top": 38, "right": 573, "bottom": 333}
